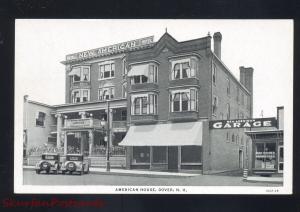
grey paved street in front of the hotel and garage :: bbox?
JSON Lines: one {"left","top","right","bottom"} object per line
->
{"left": 23, "top": 169, "right": 281, "bottom": 186}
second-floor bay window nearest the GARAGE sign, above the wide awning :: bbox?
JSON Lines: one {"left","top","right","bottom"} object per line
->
{"left": 170, "top": 88, "right": 198, "bottom": 112}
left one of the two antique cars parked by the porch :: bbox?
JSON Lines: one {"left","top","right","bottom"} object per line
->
{"left": 35, "top": 153, "right": 61, "bottom": 174}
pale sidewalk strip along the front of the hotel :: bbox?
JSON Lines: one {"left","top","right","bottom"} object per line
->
{"left": 23, "top": 166, "right": 201, "bottom": 177}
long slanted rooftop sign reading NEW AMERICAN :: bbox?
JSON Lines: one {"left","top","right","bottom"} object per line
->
{"left": 66, "top": 36, "right": 153, "bottom": 61}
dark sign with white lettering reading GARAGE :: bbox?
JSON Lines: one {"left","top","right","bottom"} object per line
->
{"left": 209, "top": 117, "right": 277, "bottom": 129}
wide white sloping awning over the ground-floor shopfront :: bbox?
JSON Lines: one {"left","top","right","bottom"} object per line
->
{"left": 119, "top": 122, "right": 203, "bottom": 146}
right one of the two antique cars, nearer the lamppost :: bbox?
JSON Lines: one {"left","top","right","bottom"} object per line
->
{"left": 61, "top": 154, "right": 90, "bottom": 175}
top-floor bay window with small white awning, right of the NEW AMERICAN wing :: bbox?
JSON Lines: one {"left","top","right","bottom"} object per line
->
{"left": 128, "top": 63, "right": 158, "bottom": 84}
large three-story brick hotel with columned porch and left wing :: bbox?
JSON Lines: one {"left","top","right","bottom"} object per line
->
{"left": 24, "top": 32, "right": 253, "bottom": 173}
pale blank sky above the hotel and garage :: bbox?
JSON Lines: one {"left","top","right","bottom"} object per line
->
{"left": 15, "top": 19, "right": 293, "bottom": 117}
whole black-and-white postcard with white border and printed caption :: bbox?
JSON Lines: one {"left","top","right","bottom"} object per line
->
{"left": 14, "top": 19, "right": 293, "bottom": 194}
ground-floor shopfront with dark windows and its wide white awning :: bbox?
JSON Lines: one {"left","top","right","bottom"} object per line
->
{"left": 120, "top": 121, "right": 204, "bottom": 171}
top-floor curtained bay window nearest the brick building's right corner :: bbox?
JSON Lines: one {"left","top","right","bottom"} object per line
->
{"left": 171, "top": 57, "right": 197, "bottom": 80}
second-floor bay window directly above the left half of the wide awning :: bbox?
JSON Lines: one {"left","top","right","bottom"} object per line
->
{"left": 131, "top": 94, "right": 157, "bottom": 115}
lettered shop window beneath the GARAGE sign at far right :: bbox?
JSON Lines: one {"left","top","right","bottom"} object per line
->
{"left": 255, "top": 143, "right": 276, "bottom": 169}
